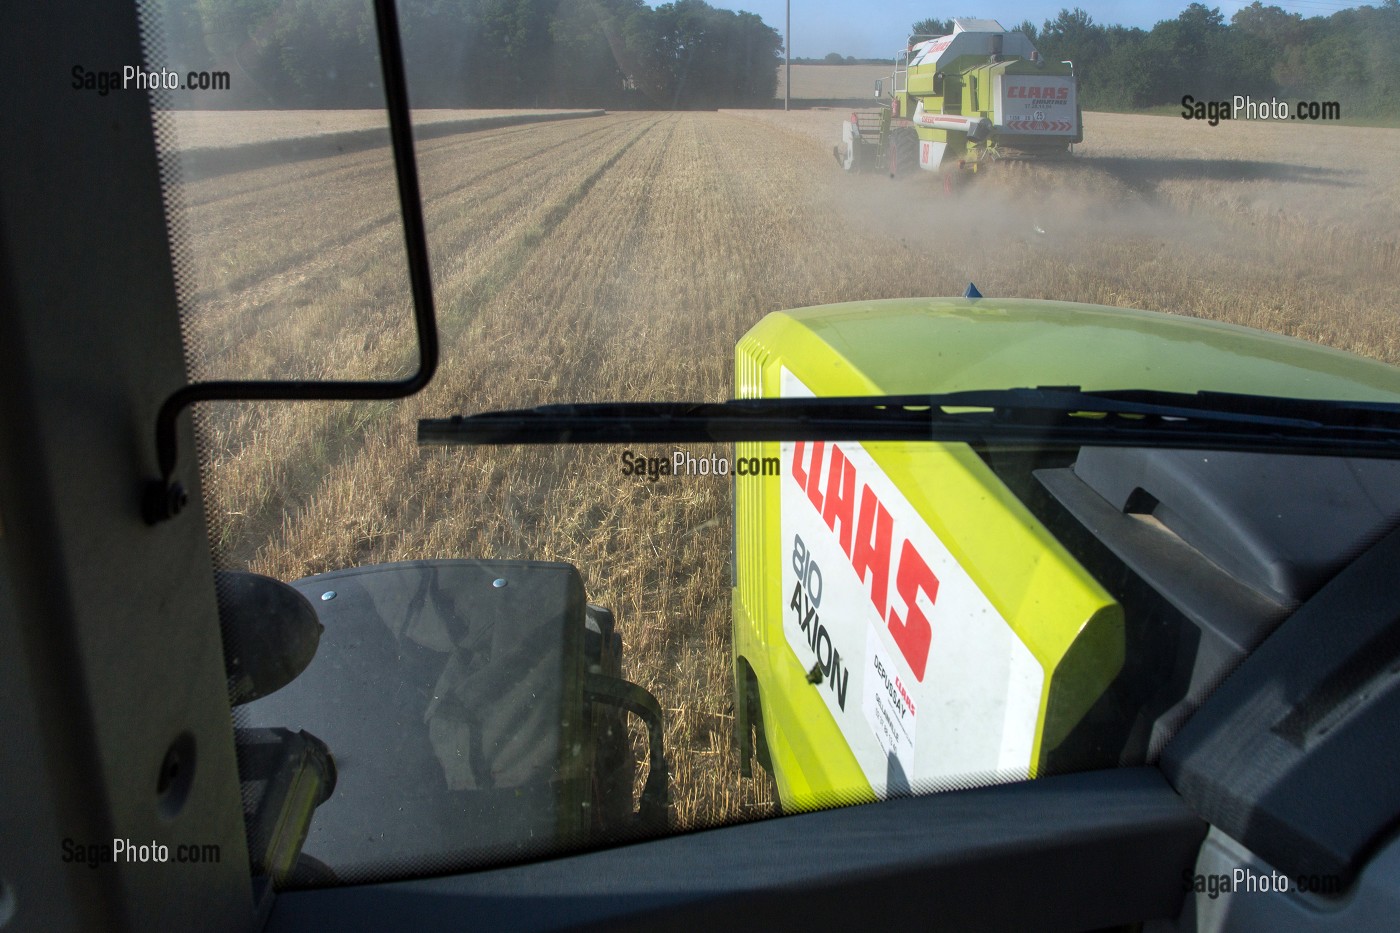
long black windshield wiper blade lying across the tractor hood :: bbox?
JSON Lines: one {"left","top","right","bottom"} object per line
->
{"left": 419, "top": 387, "right": 1400, "bottom": 458}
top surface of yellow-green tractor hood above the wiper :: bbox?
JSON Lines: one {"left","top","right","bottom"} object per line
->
{"left": 741, "top": 298, "right": 1400, "bottom": 401}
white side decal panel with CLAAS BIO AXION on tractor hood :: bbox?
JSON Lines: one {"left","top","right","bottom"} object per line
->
{"left": 778, "top": 368, "right": 1044, "bottom": 794}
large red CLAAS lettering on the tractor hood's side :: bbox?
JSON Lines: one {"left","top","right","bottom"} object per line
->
{"left": 791, "top": 441, "right": 938, "bottom": 681}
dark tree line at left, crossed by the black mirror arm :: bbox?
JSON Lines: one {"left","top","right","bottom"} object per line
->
{"left": 158, "top": 0, "right": 783, "bottom": 109}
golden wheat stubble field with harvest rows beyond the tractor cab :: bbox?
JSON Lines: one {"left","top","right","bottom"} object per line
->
{"left": 183, "top": 111, "right": 1400, "bottom": 827}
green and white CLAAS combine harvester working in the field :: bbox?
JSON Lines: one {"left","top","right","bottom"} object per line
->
{"left": 832, "top": 20, "right": 1084, "bottom": 188}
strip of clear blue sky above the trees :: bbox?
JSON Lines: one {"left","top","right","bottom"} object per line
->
{"left": 708, "top": 0, "right": 1360, "bottom": 59}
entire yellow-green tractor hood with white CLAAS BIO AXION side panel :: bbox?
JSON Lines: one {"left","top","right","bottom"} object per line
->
{"left": 734, "top": 298, "right": 1400, "bottom": 807}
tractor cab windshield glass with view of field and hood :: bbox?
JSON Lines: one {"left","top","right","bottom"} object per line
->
{"left": 133, "top": 0, "right": 1400, "bottom": 885}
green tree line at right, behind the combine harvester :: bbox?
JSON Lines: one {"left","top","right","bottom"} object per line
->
{"left": 910, "top": 0, "right": 1400, "bottom": 118}
